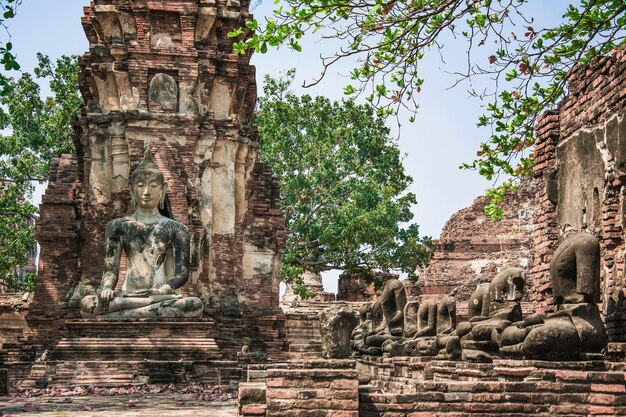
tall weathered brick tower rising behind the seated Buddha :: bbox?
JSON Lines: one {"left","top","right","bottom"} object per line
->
{"left": 29, "top": 0, "right": 285, "bottom": 355}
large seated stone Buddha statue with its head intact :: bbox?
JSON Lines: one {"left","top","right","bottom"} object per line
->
{"left": 81, "top": 152, "right": 203, "bottom": 318}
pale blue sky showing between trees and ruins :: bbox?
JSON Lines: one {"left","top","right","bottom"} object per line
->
{"left": 0, "top": 0, "right": 569, "bottom": 290}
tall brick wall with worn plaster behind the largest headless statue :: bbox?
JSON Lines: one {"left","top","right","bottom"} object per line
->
{"left": 532, "top": 49, "right": 626, "bottom": 341}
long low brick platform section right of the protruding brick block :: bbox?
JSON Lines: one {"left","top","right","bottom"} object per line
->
{"left": 357, "top": 358, "right": 626, "bottom": 417}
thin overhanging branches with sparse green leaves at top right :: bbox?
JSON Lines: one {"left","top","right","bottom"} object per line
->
{"left": 229, "top": 0, "right": 626, "bottom": 217}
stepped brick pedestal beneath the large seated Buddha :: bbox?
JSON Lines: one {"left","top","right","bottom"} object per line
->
{"left": 5, "top": 319, "right": 227, "bottom": 391}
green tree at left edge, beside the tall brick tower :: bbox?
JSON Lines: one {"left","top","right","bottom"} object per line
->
{"left": 0, "top": 54, "right": 82, "bottom": 290}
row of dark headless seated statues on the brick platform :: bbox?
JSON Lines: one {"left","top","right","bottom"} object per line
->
{"left": 351, "top": 232, "right": 607, "bottom": 362}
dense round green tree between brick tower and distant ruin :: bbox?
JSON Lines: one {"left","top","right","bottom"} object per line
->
{"left": 255, "top": 70, "right": 432, "bottom": 289}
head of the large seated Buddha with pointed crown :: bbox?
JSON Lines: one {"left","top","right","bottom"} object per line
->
{"left": 130, "top": 153, "right": 167, "bottom": 210}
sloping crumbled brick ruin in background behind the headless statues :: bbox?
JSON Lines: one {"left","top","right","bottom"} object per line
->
{"left": 407, "top": 182, "right": 534, "bottom": 319}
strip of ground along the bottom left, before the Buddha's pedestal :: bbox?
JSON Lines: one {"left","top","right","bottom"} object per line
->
{"left": 0, "top": 393, "right": 237, "bottom": 417}
